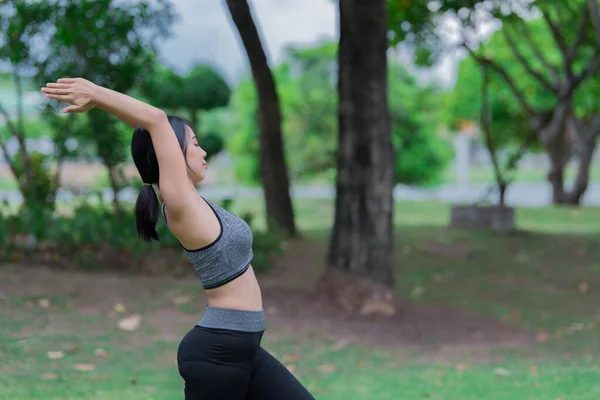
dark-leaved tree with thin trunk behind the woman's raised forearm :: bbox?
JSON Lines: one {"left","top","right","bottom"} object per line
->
{"left": 37, "top": 0, "right": 176, "bottom": 216}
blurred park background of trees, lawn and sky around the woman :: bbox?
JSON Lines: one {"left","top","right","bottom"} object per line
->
{"left": 0, "top": 0, "right": 600, "bottom": 400}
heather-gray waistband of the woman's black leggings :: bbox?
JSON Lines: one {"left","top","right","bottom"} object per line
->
{"left": 197, "top": 306, "right": 265, "bottom": 332}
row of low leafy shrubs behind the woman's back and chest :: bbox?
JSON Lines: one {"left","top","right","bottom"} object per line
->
{"left": 0, "top": 196, "right": 281, "bottom": 271}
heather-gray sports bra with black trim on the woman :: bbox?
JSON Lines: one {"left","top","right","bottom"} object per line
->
{"left": 162, "top": 197, "right": 254, "bottom": 289}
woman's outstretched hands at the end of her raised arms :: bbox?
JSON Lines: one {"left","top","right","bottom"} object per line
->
{"left": 42, "top": 78, "right": 97, "bottom": 113}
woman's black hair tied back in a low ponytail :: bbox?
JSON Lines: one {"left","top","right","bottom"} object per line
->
{"left": 131, "top": 115, "right": 191, "bottom": 242}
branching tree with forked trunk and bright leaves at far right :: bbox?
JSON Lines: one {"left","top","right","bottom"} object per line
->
{"left": 391, "top": 0, "right": 600, "bottom": 204}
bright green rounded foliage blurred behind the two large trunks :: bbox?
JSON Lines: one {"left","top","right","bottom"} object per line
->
{"left": 227, "top": 44, "right": 452, "bottom": 184}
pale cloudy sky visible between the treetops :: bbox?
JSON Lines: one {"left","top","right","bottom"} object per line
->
{"left": 159, "top": 0, "right": 464, "bottom": 84}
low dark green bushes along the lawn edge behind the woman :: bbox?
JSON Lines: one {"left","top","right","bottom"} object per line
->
{"left": 0, "top": 193, "right": 285, "bottom": 271}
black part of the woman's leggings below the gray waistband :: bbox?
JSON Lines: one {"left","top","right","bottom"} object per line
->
{"left": 177, "top": 326, "right": 315, "bottom": 400}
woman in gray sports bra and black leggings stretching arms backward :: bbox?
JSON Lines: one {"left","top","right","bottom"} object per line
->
{"left": 42, "top": 78, "right": 314, "bottom": 400}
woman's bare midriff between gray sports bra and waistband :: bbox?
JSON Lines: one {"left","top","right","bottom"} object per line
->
{"left": 205, "top": 266, "right": 263, "bottom": 311}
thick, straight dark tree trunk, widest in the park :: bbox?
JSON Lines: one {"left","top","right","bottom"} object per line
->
{"left": 328, "top": 0, "right": 394, "bottom": 287}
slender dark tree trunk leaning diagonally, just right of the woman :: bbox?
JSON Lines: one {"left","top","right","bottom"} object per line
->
{"left": 227, "top": 0, "right": 297, "bottom": 235}
